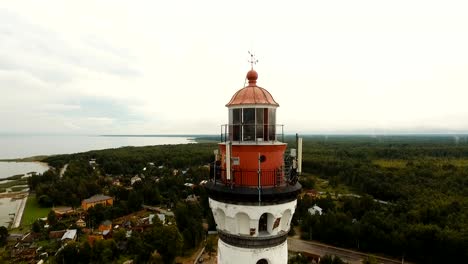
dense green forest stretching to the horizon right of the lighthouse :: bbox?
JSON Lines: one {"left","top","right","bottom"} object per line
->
{"left": 295, "top": 136, "right": 468, "bottom": 263}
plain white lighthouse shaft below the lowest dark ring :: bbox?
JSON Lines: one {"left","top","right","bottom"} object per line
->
{"left": 218, "top": 239, "right": 288, "bottom": 264}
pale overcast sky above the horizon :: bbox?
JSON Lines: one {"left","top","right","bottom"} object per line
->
{"left": 0, "top": 0, "right": 468, "bottom": 134}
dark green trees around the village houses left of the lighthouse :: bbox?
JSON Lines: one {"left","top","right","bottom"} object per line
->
{"left": 28, "top": 144, "right": 216, "bottom": 263}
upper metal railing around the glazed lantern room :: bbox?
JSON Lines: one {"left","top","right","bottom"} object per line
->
{"left": 220, "top": 124, "right": 284, "bottom": 143}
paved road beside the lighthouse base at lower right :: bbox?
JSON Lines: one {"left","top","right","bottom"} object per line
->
{"left": 288, "top": 237, "right": 411, "bottom": 264}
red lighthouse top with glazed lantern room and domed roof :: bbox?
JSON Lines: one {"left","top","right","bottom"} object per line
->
{"left": 219, "top": 70, "right": 286, "bottom": 187}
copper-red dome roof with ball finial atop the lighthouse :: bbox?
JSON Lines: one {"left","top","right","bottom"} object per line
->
{"left": 226, "top": 70, "right": 279, "bottom": 107}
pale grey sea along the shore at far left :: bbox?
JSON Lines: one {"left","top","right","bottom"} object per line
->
{"left": 0, "top": 135, "right": 194, "bottom": 226}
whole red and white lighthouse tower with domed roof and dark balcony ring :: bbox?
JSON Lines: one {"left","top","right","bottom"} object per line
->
{"left": 206, "top": 62, "right": 301, "bottom": 264}
